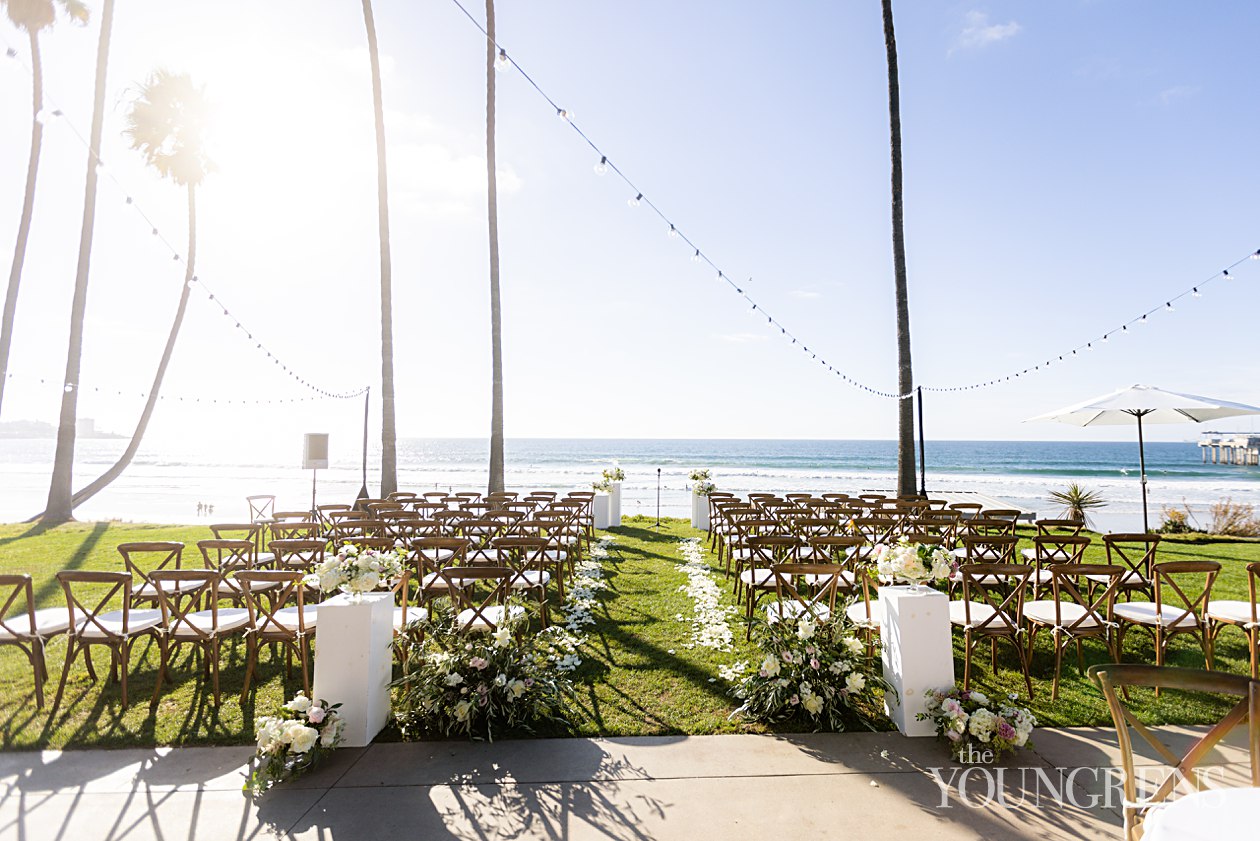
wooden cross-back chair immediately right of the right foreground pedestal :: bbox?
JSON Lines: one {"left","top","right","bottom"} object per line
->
{"left": 949, "top": 564, "right": 1032, "bottom": 699}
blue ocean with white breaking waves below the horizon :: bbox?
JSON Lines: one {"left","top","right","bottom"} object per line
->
{"left": 0, "top": 438, "right": 1260, "bottom": 531}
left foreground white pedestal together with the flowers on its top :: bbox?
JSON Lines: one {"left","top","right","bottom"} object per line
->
{"left": 307, "top": 546, "right": 402, "bottom": 748}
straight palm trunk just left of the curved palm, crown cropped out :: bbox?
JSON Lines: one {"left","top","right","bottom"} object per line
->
{"left": 39, "top": 0, "right": 113, "bottom": 523}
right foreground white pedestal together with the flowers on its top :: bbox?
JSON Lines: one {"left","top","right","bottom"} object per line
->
{"left": 874, "top": 541, "right": 954, "bottom": 736}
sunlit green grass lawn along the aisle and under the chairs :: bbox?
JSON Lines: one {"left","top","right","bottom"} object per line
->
{"left": 0, "top": 518, "right": 1260, "bottom": 748}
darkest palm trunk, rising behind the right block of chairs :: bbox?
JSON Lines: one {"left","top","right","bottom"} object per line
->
{"left": 882, "top": 0, "right": 915, "bottom": 496}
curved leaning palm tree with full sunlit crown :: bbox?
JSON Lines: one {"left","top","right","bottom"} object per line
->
{"left": 49, "top": 71, "right": 214, "bottom": 509}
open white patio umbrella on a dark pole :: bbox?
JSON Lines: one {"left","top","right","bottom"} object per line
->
{"left": 1024, "top": 386, "right": 1260, "bottom": 531}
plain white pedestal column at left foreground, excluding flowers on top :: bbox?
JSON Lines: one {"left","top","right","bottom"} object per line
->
{"left": 314, "top": 593, "right": 394, "bottom": 748}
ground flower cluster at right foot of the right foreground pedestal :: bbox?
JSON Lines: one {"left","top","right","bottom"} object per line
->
{"left": 919, "top": 686, "right": 1037, "bottom": 764}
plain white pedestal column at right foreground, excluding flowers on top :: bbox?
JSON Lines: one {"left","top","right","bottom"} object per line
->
{"left": 879, "top": 586, "right": 954, "bottom": 736}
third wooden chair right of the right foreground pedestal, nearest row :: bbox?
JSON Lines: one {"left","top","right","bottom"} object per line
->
{"left": 1115, "top": 561, "right": 1221, "bottom": 670}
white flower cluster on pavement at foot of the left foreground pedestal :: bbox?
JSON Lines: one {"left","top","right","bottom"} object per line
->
{"left": 244, "top": 692, "right": 345, "bottom": 794}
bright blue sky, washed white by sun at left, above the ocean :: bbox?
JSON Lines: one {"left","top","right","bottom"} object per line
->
{"left": 0, "top": 0, "right": 1260, "bottom": 453}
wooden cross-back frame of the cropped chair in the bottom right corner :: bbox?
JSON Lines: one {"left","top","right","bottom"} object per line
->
{"left": 1089, "top": 663, "right": 1260, "bottom": 841}
